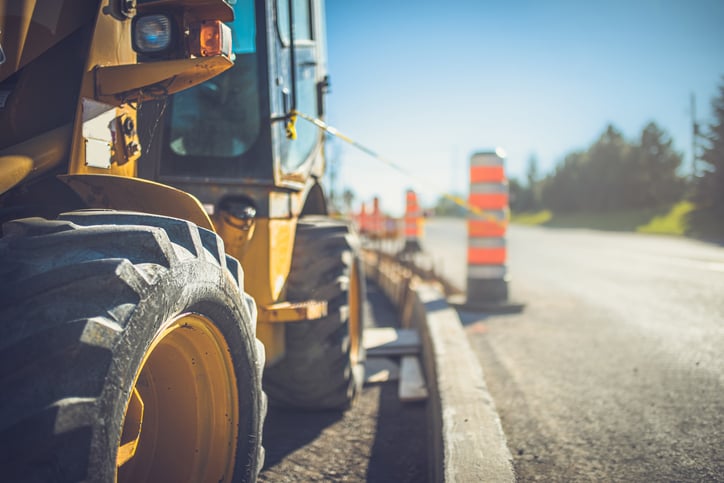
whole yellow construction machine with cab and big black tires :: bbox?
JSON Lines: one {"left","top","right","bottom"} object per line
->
{"left": 0, "top": 0, "right": 364, "bottom": 482}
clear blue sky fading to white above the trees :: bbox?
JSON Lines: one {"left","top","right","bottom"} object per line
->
{"left": 326, "top": 0, "right": 724, "bottom": 216}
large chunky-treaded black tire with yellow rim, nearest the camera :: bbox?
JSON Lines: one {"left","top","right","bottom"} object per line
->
{"left": 0, "top": 210, "right": 266, "bottom": 482}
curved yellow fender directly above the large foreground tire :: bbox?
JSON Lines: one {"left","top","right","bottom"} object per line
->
{"left": 59, "top": 174, "right": 214, "bottom": 230}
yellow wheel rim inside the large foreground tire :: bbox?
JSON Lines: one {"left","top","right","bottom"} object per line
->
{"left": 116, "top": 314, "right": 239, "bottom": 482}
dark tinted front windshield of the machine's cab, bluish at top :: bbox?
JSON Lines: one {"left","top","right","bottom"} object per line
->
{"left": 167, "top": 0, "right": 261, "bottom": 162}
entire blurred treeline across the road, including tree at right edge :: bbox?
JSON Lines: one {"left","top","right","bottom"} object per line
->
{"left": 510, "top": 78, "right": 724, "bottom": 225}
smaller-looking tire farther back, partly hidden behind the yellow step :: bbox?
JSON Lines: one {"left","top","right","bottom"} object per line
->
{"left": 264, "top": 216, "right": 365, "bottom": 409}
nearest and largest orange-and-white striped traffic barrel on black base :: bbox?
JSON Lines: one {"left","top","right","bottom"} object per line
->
{"left": 465, "top": 152, "right": 519, "bottom": 310}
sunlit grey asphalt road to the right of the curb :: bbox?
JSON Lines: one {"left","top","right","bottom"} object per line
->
{"left": 423, "top": 220, "right": 724, "bottom": 482}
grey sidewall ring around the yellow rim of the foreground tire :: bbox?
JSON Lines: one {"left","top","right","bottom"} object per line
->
{"left": 90, "top": 259, "right": 262, "bottom": 481}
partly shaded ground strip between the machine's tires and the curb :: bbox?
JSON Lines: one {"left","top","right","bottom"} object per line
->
{"left": 259, "top": 281, "right": 429, "bottom": 483}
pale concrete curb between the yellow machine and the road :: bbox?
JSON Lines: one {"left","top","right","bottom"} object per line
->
{"left": 365, "top": 254, "right": 515, "bottom": 483}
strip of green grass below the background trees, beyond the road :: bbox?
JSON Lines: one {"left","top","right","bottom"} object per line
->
{"left": 511, "top": 201, "right": 695, "bottom": 235}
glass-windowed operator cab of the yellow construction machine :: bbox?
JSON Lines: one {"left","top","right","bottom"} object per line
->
{"left": 139, "top": 0, "right": 327, "bottom": 209}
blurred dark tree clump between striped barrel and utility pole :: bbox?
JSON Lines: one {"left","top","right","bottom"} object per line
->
{"left": 510, "top": 122, "right": 686, "bottom": 213}
